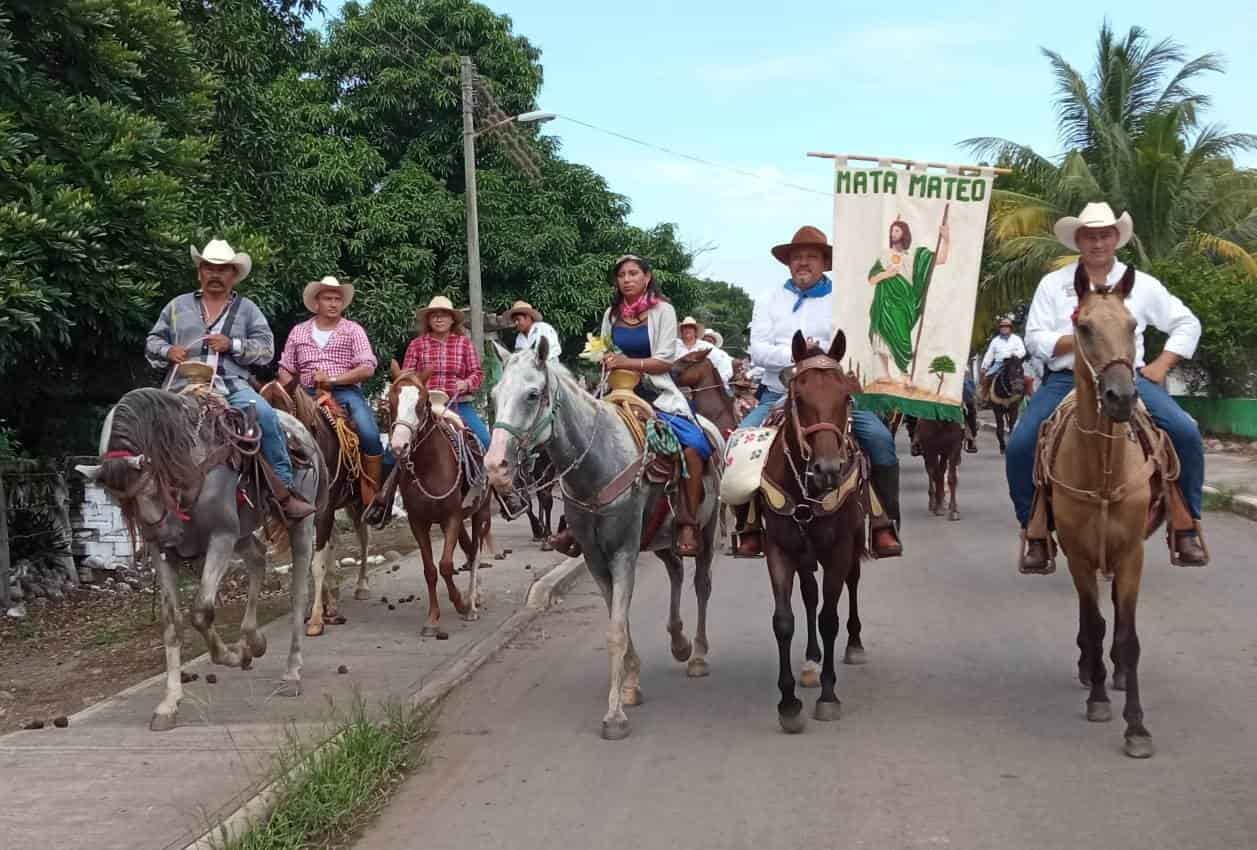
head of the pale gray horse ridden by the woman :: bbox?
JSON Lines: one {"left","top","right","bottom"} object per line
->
{"left": 484, "top": 337, "right": 558, "bottom": 492}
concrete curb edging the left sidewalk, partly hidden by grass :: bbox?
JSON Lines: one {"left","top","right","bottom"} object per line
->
{"left": 184, "top": 557, "right": 585, "bottom": 850}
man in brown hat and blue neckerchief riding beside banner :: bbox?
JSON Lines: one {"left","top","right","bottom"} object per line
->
{"left": 738, "top": 226, "right": 903, "bottom": 557}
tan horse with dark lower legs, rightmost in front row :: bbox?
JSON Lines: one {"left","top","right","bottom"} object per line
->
{"left": 1047, "top": 264, "right": 1151, "bottom": 758}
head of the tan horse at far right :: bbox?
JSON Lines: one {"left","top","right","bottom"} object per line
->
{"left": 1073, "top": 263, "right": 1136, "bottom": 422}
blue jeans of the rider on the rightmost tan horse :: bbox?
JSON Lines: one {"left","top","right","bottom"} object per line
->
{"left": 1004, "top": 372, "right": 1204, "bottom": 528}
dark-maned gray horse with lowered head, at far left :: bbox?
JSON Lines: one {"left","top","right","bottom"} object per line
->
{"left": 75, "top": 389, "right": 327, "bottom": 732}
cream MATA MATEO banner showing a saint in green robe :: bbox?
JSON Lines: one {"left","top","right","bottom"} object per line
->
{"left": 833, "top": 156, "right": 994, "bottom": 421}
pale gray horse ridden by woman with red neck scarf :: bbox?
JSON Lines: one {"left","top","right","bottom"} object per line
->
{"left": 485, "top": 338, "right": 724, "bottom": 741}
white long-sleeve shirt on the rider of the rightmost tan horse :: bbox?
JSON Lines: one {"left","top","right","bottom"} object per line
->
{"left": 1026, "top": 263, "right": 1200, "bottom": 372}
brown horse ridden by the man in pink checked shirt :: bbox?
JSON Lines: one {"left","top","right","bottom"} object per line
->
{"left": 259, "top": 381, "right": 371, "bottom": 638}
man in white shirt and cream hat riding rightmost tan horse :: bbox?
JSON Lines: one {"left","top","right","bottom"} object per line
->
{"left": 1006, "top": 204, "right": 1208, "bottom": 573}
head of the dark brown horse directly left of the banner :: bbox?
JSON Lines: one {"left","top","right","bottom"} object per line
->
{"left": 786, "top": 331, "right": 854, "bottom": 497}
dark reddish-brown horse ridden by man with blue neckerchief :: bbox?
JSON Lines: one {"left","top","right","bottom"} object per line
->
{"left": 757, "top": 331, "right": 865, "bottom": 732}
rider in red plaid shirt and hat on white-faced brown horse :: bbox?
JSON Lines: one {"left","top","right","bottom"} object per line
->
{"left": 401, "top": 295, "right": 489, "bottom": 449}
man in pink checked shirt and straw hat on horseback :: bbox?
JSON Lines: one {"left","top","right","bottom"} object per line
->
{"left": 279, "top": 275, "right": 392, "bottom": 489}
